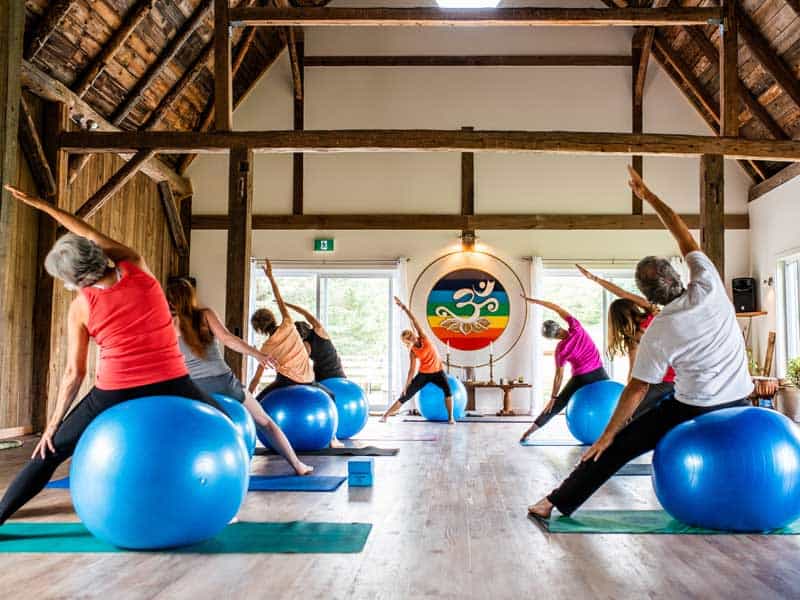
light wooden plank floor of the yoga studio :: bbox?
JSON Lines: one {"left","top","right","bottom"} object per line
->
{"left": 0, "top": 418, "right": 800, "bottom": 600}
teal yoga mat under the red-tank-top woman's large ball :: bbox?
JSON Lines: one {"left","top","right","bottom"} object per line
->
{"left": 0, "top": 521, "right": 372, "bottom": 554}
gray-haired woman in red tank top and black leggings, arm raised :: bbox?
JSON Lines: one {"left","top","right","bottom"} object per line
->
{"left": 0, "top": 186, "right": 228, "bottom": 524}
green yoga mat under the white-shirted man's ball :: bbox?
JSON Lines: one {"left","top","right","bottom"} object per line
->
{"left": 531, "top": 510, "right": 800, "bottom": 535}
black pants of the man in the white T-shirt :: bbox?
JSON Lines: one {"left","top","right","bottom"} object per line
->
{"left": 547, "top": 398, "right": 749, "bottom": 515}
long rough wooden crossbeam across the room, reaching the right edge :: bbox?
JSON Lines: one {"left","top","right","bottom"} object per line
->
{"left": 60, "top": 129, "right": 800, "bottom": 161}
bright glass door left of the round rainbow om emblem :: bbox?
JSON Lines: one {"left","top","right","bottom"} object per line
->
{"left": 248, "top": 268, "right": 395, "bottom": 408}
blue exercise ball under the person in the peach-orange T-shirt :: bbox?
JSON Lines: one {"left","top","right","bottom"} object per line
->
{"left": 258, "top": 385, "right": 339, "bottom": 452}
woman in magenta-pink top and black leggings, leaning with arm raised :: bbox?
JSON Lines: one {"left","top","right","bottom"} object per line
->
{"left": 522, "top": 298, "right": 608, "bottom": 441}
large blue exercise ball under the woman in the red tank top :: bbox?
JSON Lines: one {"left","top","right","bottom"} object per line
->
{"left": 70, "top": 396, "right": 249, "bottom": 550}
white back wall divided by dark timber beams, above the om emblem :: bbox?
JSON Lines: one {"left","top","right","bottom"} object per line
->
{"left": 189, "top": 22, "right": 750, "bottom": 408}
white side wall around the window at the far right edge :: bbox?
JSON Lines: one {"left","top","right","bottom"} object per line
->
{"left": 749, "top": 179, "right": 800, "bottom": 376}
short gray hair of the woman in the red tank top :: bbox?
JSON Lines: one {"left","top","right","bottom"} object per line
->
{"left": 44, "top": 233, "right": 109, "bottom": 290}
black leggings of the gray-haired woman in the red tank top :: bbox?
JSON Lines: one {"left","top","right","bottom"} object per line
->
{"left": 0, "top": 375, "right": 222, "bottom": 525}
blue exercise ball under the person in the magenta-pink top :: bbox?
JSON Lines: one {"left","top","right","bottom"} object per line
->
{"left": 567, "top": 380, "right": 625, "bottom": 444}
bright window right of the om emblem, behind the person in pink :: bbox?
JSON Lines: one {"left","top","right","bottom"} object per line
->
{"left": 540, "top": 268, "right": 639, "bottom": 402}
